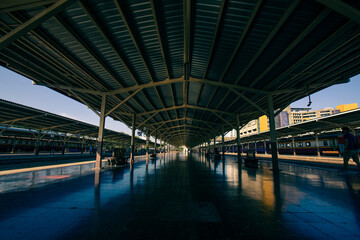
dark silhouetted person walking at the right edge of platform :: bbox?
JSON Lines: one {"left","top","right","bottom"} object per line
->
{"left": 341, "top": 127, "right": 360, "bottom": 173}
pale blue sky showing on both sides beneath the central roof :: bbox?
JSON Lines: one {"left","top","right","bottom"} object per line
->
{"left": 0, "top": 67, "right": 360, "bottom": 134}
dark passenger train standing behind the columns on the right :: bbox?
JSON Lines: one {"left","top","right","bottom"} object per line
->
{"left": 212, "top": 133, "right": 360, "bottom": 156}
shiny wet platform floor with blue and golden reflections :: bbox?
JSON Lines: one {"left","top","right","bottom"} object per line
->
{"left": 0, "top": 153, "right": 360, "bottom": 239}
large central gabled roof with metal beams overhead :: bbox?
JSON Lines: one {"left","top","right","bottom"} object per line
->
{"left": 0, "top": 0, "right": 360, "bottom": 147}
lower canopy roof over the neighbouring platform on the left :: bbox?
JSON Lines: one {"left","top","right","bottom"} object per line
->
{"left": 0, "top": 99, "right": 145, "bottom": 145}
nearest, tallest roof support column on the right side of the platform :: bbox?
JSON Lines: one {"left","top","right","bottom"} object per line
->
{"left": 268, "top": 94, "right": 279, "bottom": 172}
